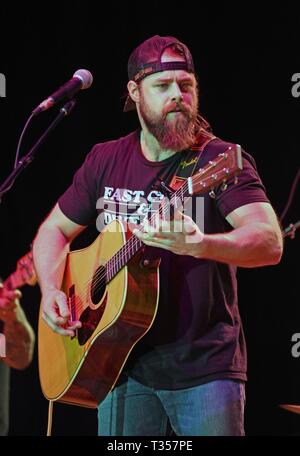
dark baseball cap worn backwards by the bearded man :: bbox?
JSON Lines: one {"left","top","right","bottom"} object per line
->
{"left": 123, "top": 35, "right": 195, "bottom": 112}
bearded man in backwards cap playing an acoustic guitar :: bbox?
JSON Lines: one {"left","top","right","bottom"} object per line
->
{"left": 34, "top": 36, "right": 282, "bottom": 435}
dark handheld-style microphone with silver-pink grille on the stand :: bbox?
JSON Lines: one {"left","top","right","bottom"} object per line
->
{"left": 32, "top": 70, "right": 93, "bottom": 116}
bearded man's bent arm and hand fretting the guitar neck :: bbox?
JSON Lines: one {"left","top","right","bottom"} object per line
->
{"left": 134, "top": 202, "right": 283, "bottom": 268}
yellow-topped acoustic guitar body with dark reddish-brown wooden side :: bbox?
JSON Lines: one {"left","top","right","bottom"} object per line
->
{"left": 38, "top": 221, "right": 159, "bottom": 408}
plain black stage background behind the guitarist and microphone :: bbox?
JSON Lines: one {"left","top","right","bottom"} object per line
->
{"left": 0, "top": 0, "right": 300, "bottom": 435}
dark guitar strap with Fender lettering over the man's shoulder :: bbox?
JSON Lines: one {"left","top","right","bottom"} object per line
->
{"left": 169, "top": 131, "right": 216, "bottom": 191}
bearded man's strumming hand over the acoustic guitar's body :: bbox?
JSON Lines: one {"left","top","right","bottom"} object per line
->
{"left": 41, "top": 288, "right": 82, "bottom": 336}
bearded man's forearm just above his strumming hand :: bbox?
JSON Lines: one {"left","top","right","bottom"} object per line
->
{"left": 33, "top": 222, "right": 69, "bottom": 292}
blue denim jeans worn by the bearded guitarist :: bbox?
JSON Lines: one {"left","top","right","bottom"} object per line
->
{"left": 98, "top": 378, "right": 245, "bottom": 436}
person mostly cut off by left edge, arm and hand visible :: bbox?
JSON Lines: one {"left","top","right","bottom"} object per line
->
{"left": 0, "top": 284, "right": 35, "bottom": 436}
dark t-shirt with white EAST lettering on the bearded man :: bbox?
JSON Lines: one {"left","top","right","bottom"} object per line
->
{"left": 58, "top": 131, "right": 268, "bottom": 389}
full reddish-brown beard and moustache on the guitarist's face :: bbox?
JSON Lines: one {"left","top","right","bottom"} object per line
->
{"left": 140, "top": 93, "right": 200, "bottom": 152}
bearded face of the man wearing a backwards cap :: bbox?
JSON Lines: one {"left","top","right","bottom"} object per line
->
{"left": 139, "top": 64, "right": 198, "bottom": 152}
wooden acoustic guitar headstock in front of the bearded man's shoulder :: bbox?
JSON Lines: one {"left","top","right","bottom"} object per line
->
{"left": 188, "top": 144, "right": 243, "bottom": 195}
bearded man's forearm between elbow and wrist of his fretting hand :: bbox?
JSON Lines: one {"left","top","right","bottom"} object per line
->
{"left": 195, "top": 222, "right": 282, "bottom": 268}
